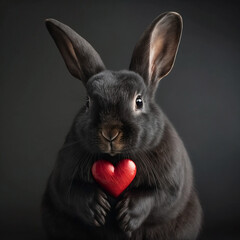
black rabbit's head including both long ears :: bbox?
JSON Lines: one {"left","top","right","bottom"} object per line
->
{"left": 46, "top": 12, "right": 182, "bottom": 156}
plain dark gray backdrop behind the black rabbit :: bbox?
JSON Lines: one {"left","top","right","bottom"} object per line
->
{"left": 0, "top": 0, "right": 240, "bottom": 240}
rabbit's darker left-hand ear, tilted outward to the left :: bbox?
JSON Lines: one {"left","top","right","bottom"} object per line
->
{"left": 46, "top": 19, "right": 105, "bottom": 84}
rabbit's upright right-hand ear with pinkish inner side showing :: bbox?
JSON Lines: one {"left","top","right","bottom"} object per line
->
{"left": 129, "top": 12, "right": 182, "bottom": 88}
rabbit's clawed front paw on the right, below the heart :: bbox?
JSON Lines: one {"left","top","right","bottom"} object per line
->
{"left": 116, "top": 191, "right": 154, "bottom": 237}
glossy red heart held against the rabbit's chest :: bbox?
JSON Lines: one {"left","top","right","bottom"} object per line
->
{"left": 92, "top": 159, "right": 137, "bottom": 197}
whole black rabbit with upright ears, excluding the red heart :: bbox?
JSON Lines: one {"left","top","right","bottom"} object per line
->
{"left": 41, "top": 12, "right": 202, "bottom": 240}
